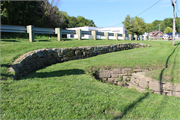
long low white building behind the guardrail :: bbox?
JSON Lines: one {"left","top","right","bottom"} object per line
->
{"left": 66, "top": 26, "right": 127, "bottom": 39}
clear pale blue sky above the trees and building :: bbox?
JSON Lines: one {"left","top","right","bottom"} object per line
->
{"left": 58, "top": 0, "right": 180, "bottom": 27}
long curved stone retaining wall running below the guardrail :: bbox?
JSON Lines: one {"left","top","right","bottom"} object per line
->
{"left": 10, "top": 43, "right": 150, "bottom": 79}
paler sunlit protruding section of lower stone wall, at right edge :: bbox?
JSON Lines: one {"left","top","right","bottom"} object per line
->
{"left": 129, "top": 72, "right": 180, "bottom": 97}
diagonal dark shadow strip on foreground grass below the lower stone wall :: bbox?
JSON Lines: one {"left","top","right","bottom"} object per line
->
{"left": 113, "top": 92, "right": 149, "bottom": 119}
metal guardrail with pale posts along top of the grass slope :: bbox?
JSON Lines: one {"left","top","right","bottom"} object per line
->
{"left": 0, "top": 25, "right": 147, "bottom": 42}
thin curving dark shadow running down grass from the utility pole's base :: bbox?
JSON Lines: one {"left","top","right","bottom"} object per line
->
{"left": 159, "top": 43, "right": 179, "bottom": 95}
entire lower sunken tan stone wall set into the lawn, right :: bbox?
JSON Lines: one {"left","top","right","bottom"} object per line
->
{"left": 96, "top": 68, "right": 180, "bottom": 97}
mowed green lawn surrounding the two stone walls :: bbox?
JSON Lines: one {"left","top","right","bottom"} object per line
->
{"left": 1, "top": 39, "right": 180, "bottom": 119}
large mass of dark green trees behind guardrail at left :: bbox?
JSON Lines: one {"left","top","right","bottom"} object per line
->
{"left": 1, "top": 0, "right": 96, "bottom": 29}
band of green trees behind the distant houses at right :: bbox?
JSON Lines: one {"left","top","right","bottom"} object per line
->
{"left": 123, "top": 15, "right": 180, "bottom": 35}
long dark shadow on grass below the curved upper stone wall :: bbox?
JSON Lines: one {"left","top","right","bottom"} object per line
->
{"left": 24, "top": 69, "right": 85, "bottom": 78}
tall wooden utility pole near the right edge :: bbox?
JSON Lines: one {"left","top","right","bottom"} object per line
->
{"left": 171, "top": 0, "right": 176, "bottom": 46}
